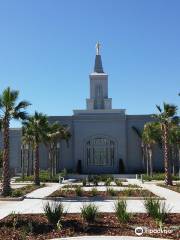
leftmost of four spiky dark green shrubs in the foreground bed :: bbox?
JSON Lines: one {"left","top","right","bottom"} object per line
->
{"left": 44, "top": 202, "right": 64, "bottom": 227}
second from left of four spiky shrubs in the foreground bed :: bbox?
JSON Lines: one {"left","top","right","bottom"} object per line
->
{"left": 81, "top": 203, "right": 99, "bottom": 224}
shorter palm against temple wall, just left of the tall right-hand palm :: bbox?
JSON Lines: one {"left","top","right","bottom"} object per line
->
{"left": 142, "top": 122, "right": 161, "bottom": 176}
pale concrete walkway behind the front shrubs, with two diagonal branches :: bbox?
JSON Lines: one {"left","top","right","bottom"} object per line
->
{"left": 0, "top": 179, "right": 180, "bottom": 219}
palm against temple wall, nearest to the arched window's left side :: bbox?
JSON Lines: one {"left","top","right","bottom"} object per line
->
{"left": 46, "top": 122, "right": 71, "bottom": 178}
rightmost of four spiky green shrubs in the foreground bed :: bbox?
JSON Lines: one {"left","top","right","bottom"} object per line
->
{"left": 144, "top": 198, "right": 170, "bottom": 224}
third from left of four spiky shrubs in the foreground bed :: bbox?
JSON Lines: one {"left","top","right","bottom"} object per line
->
{"left": 114, "top": 200, "right": 130, "bottom": 223}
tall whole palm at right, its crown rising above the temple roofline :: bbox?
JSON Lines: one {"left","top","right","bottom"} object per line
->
{"left": 154, "top": 103, "right": 179, "bottom": 185}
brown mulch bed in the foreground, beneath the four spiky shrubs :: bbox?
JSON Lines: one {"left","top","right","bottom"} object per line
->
{"left": 0, "top": 213, "right": 180, "bottom": 240}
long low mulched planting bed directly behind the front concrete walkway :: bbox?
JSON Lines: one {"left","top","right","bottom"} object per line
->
{"left": 49, "top": 188, "right": 156, "bottom": 199}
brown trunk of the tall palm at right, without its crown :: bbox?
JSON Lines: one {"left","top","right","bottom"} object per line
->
{"left": 163, "top": 124, "right": 172, "bottom": 185}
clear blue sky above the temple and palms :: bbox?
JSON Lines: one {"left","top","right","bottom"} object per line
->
{"left": 0, "top": 0, "right": 180, "bottom": 126}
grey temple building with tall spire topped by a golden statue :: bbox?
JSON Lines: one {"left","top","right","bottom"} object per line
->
{"left": 1, "top": 43, "right": 163, "bottom": 174}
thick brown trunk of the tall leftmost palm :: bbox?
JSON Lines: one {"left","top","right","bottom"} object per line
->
{"left": 2, "top": 116, "right": 11, "bottom": 196}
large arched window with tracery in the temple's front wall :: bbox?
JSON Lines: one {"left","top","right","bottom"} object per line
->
{"left": 86, "top": 137, "right": 115, "bottom": 166}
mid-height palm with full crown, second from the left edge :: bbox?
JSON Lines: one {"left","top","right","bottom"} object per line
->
{"left": 23, "top": 112, "right": 49, "bottom": 185}
